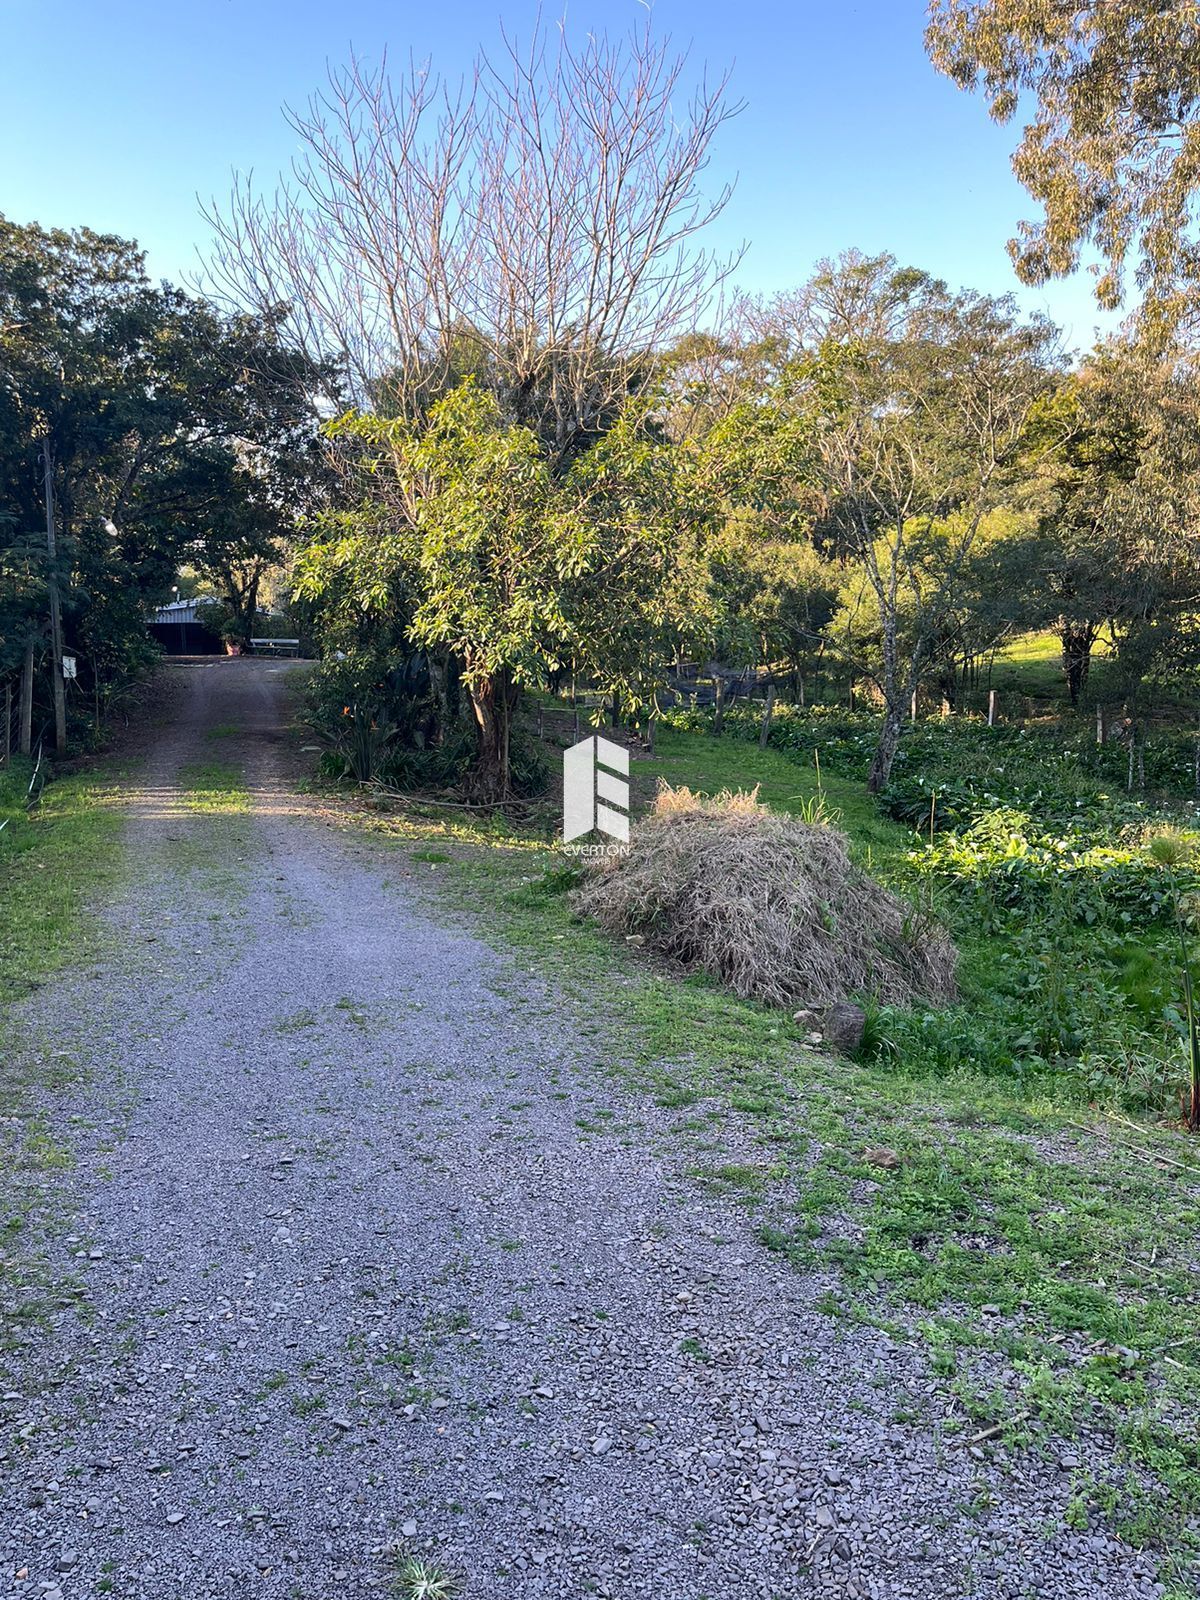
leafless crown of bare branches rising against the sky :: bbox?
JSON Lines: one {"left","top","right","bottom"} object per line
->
{"left": 208, "top": 26, "right": 739, "bottom": 461}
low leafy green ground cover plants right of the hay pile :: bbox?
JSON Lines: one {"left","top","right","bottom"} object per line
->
{"left": 662, "top": 709, "right": 1198, "bottom": 1114}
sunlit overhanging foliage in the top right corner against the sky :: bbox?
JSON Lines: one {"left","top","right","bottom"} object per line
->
{"left": 926, "top": 0, "right": 1200, "bottom": 325}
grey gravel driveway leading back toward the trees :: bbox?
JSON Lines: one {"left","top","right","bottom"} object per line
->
{"left": 0, "top": 661, "right": 1162, "bottom": 1600}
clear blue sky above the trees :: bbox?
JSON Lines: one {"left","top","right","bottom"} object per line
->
{"left": 0, "top": 0, "right": 1112, "bottom": 347}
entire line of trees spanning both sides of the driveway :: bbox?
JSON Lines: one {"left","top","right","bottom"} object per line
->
{"left": 9, "top": 18, "right": 1200, "bottom": 802}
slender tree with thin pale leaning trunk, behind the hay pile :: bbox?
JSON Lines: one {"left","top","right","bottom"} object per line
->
{"left": 797, "top": 254, "right": 1058, "bottom": 792}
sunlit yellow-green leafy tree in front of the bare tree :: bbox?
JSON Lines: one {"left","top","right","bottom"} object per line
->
{"left": 296, "top": 382, "right": 704, "bottom": 803}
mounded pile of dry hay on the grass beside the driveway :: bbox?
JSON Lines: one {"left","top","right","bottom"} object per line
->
{"left": 574, "top": 787, "right": 955, "bottom": 1006}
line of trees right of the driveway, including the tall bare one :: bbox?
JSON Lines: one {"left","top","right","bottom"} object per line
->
{"left": 211, "top": 30, "right": 1200, "bottom": 800}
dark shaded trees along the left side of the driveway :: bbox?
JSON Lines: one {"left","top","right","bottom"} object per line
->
{"left": 0, "top": 218, "right": 330, "bottom": 747}
